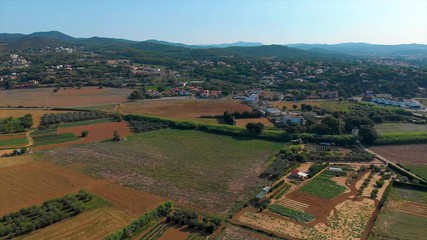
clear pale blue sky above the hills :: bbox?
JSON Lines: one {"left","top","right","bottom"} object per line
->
{"left": 0, "top": 0, "right": 427, "bottom": 44}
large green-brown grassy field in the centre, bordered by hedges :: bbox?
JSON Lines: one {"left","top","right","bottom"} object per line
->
{"left": 48, "top": 129, "right": 283, "bottom": 213}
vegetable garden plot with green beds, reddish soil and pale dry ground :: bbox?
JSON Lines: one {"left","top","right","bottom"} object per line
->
{"left": 232, "top": 165, "right": 383, "bottom": 239}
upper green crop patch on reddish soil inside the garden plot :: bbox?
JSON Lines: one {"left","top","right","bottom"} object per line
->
{"left": 299, "top": 173, "right": 347, "bottom": 199}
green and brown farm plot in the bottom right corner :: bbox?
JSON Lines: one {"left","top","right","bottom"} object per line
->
{"left": 369, "top": 187, "right": 427, "bottom": 239}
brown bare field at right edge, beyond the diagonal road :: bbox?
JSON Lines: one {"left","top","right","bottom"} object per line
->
{"left": 369, "top": 144, "right": 427, "bottom": 164}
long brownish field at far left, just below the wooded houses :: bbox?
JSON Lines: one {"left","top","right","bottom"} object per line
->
{"left": 0, "top": 87, "right": 132, "bottom": 107}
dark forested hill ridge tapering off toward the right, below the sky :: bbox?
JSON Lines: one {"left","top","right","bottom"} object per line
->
{"left": 0, "top": 31, "right": 344, "bottom": 60}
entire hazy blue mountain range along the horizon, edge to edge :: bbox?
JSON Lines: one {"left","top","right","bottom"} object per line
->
{"left": 0, "top": 31, "right": 427, "bottom": 59}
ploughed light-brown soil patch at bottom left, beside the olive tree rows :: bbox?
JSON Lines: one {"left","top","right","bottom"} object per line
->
{"left": 19, "top": 206, "right": 133, "bottom": 240}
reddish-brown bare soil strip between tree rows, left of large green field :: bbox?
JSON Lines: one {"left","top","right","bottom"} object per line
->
{"left": 33, "top": 121, "right": 132, "bottom": 151}
